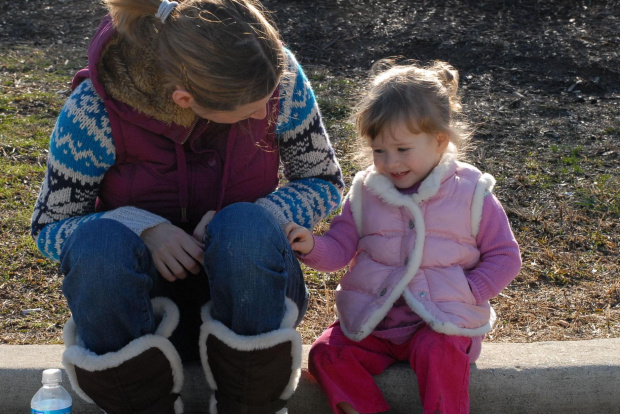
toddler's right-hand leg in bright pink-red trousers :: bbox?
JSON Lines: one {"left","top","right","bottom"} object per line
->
{"left": 409, "top": 325, "right": 472, "bottom": 414}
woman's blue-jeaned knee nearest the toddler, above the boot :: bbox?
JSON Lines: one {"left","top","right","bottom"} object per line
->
{"left": 205, "top": 203, "right": 308, "bottom": 335}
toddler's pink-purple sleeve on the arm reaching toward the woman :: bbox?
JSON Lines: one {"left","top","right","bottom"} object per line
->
{"left": 299, "top": 201, "right": 359, "bottom": 272}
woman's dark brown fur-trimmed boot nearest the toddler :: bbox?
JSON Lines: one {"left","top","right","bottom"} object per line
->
{"left": 200, "top": 304, "right": 301, "bottom": 414}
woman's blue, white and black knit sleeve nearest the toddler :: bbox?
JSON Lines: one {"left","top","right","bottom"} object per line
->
{"left": 257, "top": 49, "right": 344, "bottom": 228}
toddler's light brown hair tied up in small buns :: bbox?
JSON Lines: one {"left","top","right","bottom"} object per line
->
{"left": 354, "top": 59, "right": 471, "bottom": 165}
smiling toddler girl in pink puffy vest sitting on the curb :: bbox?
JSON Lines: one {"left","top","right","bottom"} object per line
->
{"left": 285, "top": 62, "right": 521, "bottom": 414}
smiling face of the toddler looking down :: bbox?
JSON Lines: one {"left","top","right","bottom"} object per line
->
{"left": 370, "top": 122, "right": 449, "bottom": 189}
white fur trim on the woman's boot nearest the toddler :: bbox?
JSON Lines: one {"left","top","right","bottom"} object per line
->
{"left": 200, "top": 303, "right": 302, "bottom": 402}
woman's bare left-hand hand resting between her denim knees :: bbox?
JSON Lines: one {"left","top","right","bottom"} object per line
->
{"left": 140, "top": 223, "right": 204, "bottom": 282}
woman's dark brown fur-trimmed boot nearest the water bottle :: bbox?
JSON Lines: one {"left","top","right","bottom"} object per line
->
{"left": 63, "top": 298, "right": 183, "bottom": 414}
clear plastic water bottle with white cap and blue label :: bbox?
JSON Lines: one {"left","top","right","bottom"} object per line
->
{"left": 30, "top": 369, "right": 72, "bottom": 414}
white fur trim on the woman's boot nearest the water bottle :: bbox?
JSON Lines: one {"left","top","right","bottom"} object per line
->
{"left": 62, "top": 297, "right": 183, "bottom": 414}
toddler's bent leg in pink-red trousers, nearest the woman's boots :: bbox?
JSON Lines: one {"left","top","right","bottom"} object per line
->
{"left": 308, "top": 322, "right": 396, "bottom": 414}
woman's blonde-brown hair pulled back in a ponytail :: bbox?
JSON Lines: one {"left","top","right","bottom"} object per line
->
{"left": 104, "top": 0, "right": 285, "bottom": 111}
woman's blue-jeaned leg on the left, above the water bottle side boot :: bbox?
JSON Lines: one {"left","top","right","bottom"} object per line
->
{"left": 60, "top": 219, "right": 159, "bottom": 354}
